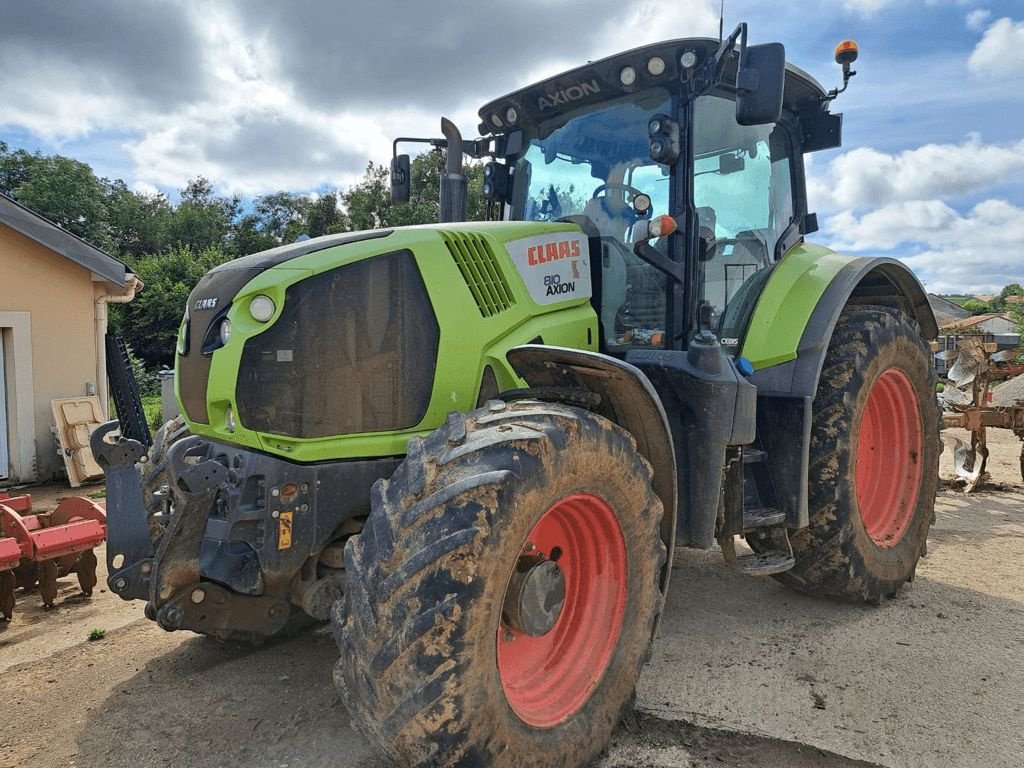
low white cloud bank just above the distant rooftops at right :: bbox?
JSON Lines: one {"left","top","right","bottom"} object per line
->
{"left": 823, "top": 199, "right": 1024, "bottom": 293}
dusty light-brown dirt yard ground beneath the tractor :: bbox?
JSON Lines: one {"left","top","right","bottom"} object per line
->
{"left": 0, "top": 430, "right": 1024, "bottom": 768}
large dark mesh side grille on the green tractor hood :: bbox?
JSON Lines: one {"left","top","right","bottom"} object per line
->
{"left": 234, "top": 251, "right": 440, "bottom": 437}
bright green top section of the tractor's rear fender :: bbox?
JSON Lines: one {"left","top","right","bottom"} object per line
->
{"left": 740, "top": 243, "right": 857, "bottom": 370}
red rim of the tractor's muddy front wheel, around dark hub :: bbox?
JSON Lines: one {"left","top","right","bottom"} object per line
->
{"left": 498, "top": 494, "right": 628, "bottom": 728}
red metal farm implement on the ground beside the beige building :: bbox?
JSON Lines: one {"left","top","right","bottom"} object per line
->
{"left": 0, "top": 494, "right": 106, "bottom": 621}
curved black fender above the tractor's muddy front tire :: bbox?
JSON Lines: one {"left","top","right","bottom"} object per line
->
{"left": 507, "top": 344, "right": 678, "bottom": 651}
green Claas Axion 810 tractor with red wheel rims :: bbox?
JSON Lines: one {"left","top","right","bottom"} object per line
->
{"left": 93, "top": 25, "right": 939, "bottom": 766}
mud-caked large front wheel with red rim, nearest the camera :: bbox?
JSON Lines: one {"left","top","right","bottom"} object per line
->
{"left": 332, "top": 401, "right": 666, "bottom": 767}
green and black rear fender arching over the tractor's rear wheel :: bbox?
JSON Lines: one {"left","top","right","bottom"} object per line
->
{"left": 741, "top": 244, "right": 938, "bottom": 527}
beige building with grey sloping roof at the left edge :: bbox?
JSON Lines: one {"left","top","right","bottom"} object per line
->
{"left": 0, "top": 195, "right": 141, "bottom": 484}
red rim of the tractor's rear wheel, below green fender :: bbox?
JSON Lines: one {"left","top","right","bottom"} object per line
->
{"left": 855, "top": 368, "right": 924, "bottom": 548}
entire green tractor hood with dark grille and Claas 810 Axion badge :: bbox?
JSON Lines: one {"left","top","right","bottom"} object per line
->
{"left": 175, "top": 222, "right": 597, "bottom": 461}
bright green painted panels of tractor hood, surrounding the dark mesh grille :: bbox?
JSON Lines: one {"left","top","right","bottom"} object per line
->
{"left": 175, "top": 222, "right": 598, "bottom": 462}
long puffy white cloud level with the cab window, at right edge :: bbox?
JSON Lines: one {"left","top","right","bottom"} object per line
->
{"left": 808, "top": 134, "right": 1024, "bottom": 210}
